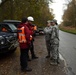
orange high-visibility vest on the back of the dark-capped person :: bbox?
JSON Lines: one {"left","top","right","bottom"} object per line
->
{"left": 18, "top": 27, "right": 26, "bottom": 43}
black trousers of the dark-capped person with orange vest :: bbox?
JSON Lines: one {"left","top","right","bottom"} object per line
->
{"left": 20, "top": 48, "right": 29, "bottom": 69}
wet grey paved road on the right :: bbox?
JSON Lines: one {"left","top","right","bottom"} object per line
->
{"left": 59, "top": 31, "right": 76, "bottom": 75}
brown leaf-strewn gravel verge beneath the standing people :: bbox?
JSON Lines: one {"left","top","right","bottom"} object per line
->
{"left": 0, "top": 36, "right": 66, "bottom": 75}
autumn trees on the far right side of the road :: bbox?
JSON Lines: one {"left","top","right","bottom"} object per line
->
{"left": 63, "top": 0, "right": 76, "bottom": 27}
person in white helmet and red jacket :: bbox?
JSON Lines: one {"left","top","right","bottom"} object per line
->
{"left": 27, "top": 16, "right": 38, "bottom": 61}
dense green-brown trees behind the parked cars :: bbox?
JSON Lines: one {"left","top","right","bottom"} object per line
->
{"left": 0, "top": 0, "right": 54, "bottom": 26}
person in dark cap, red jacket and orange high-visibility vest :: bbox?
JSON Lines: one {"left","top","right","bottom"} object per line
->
{"left": 18, "top": 17, "right": 32, "bottom": 72}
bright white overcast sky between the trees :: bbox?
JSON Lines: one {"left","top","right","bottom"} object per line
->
{"left": 49, "top": 0, "right": 66, "bottom": 23}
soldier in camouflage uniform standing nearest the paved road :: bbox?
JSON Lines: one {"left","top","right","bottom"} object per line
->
{"left": 50, "top": 20, "right": 59, "bottom": 65}
